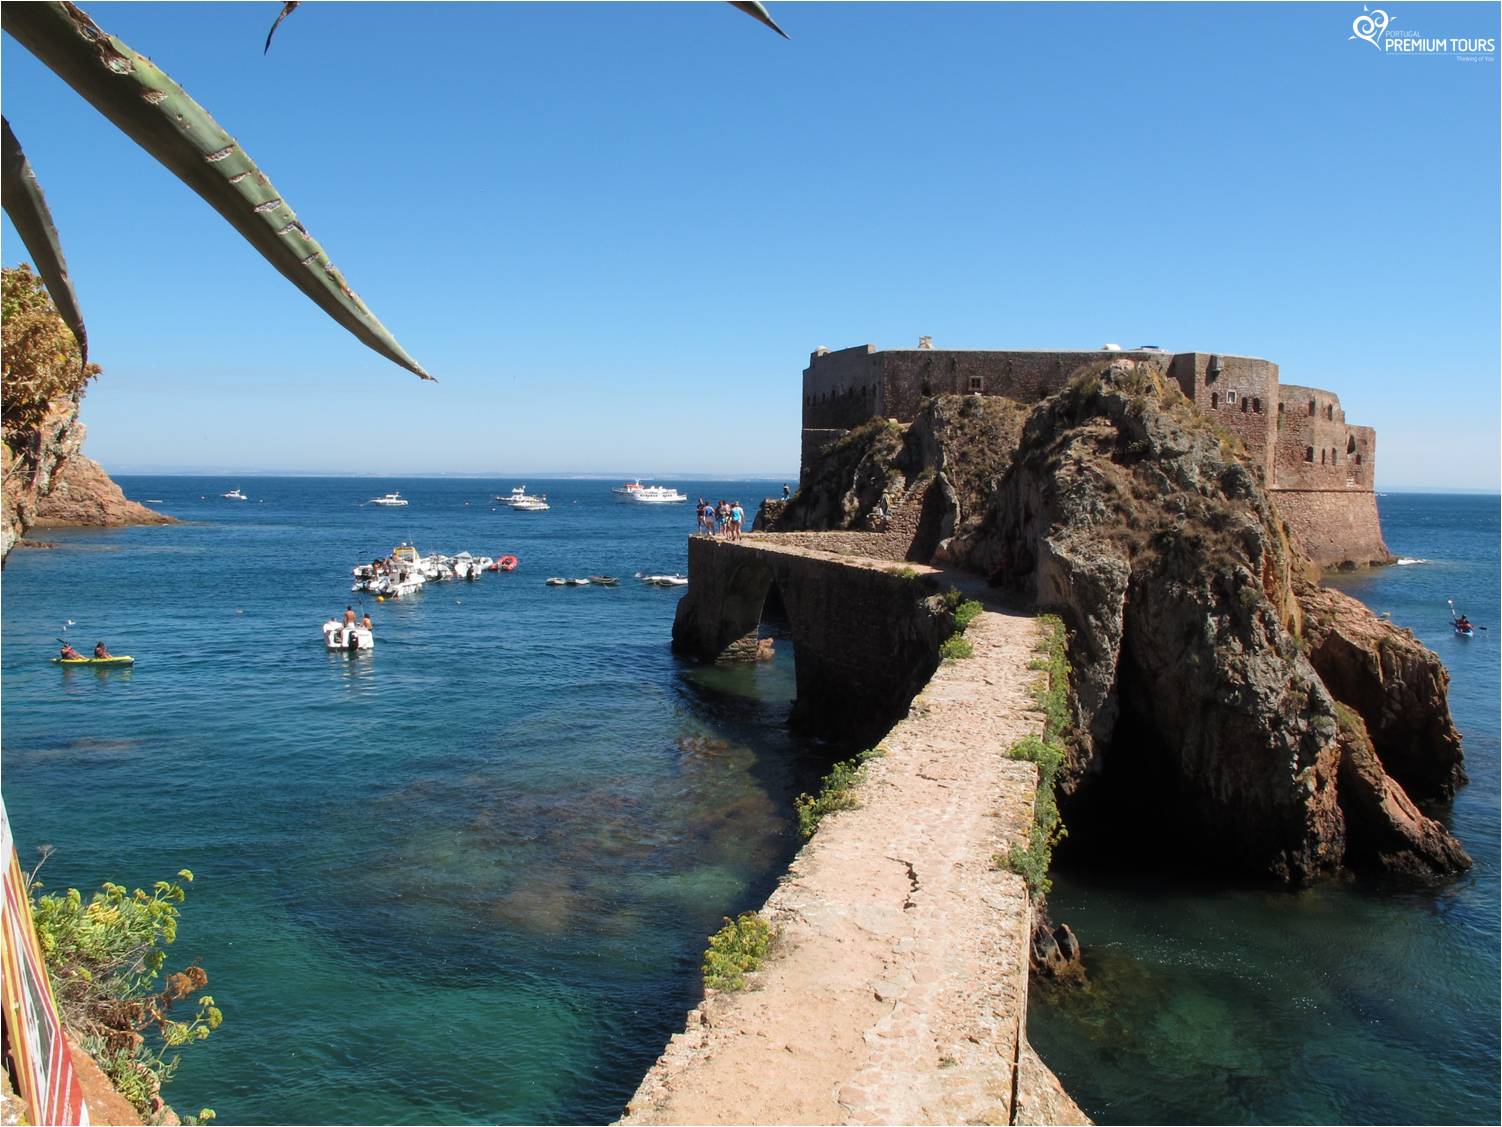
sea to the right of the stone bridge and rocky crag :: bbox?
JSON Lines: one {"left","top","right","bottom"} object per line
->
{"left": 1029, "top": 494, "right": 1502, "bottom": 1124}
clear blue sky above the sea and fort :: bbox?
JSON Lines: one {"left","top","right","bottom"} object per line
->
{"left": 3, "top": 0, "right": 1499, "bottom": 488}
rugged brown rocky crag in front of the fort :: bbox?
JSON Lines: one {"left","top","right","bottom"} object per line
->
{"left": 780, "top": 375, "right": 1469, "bottom": 884}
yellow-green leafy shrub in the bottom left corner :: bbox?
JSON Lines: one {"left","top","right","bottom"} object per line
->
{"left": 32, "top": 869, "right": 222, "bottom": 1122}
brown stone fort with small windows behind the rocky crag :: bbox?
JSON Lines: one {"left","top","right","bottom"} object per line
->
{"left": 802, "top": 337, "right": 1392, "bottom": 567}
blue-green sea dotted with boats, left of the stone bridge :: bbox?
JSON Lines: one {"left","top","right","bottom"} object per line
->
{"left": 3, "top": 478, "right": 829, "bottom": 1122}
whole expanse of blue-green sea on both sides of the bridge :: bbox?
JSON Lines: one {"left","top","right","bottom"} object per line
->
{"left": 0, "top": 476, "right": 1502, "bottom": 1122}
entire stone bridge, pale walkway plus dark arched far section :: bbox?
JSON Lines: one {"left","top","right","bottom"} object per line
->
{"left": 622, "top": 533, "right": 1089, "bottom": 1125}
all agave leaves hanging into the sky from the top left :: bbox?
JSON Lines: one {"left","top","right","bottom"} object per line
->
{"left": 0, "top": 0, "right": 786, "bottom": 380}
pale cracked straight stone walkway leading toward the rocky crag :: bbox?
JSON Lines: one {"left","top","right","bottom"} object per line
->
{"left": 622, "top": 552, "right": 1087, "bottom": 1124}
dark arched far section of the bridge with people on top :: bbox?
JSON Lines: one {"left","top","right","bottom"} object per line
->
{"left": 673, "top": 533, "right": 945, "bottom": 741}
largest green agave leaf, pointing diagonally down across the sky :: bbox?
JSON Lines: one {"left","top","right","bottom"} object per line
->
{"left": 0, "top": 2, "right": 433, "bottom": 380}
